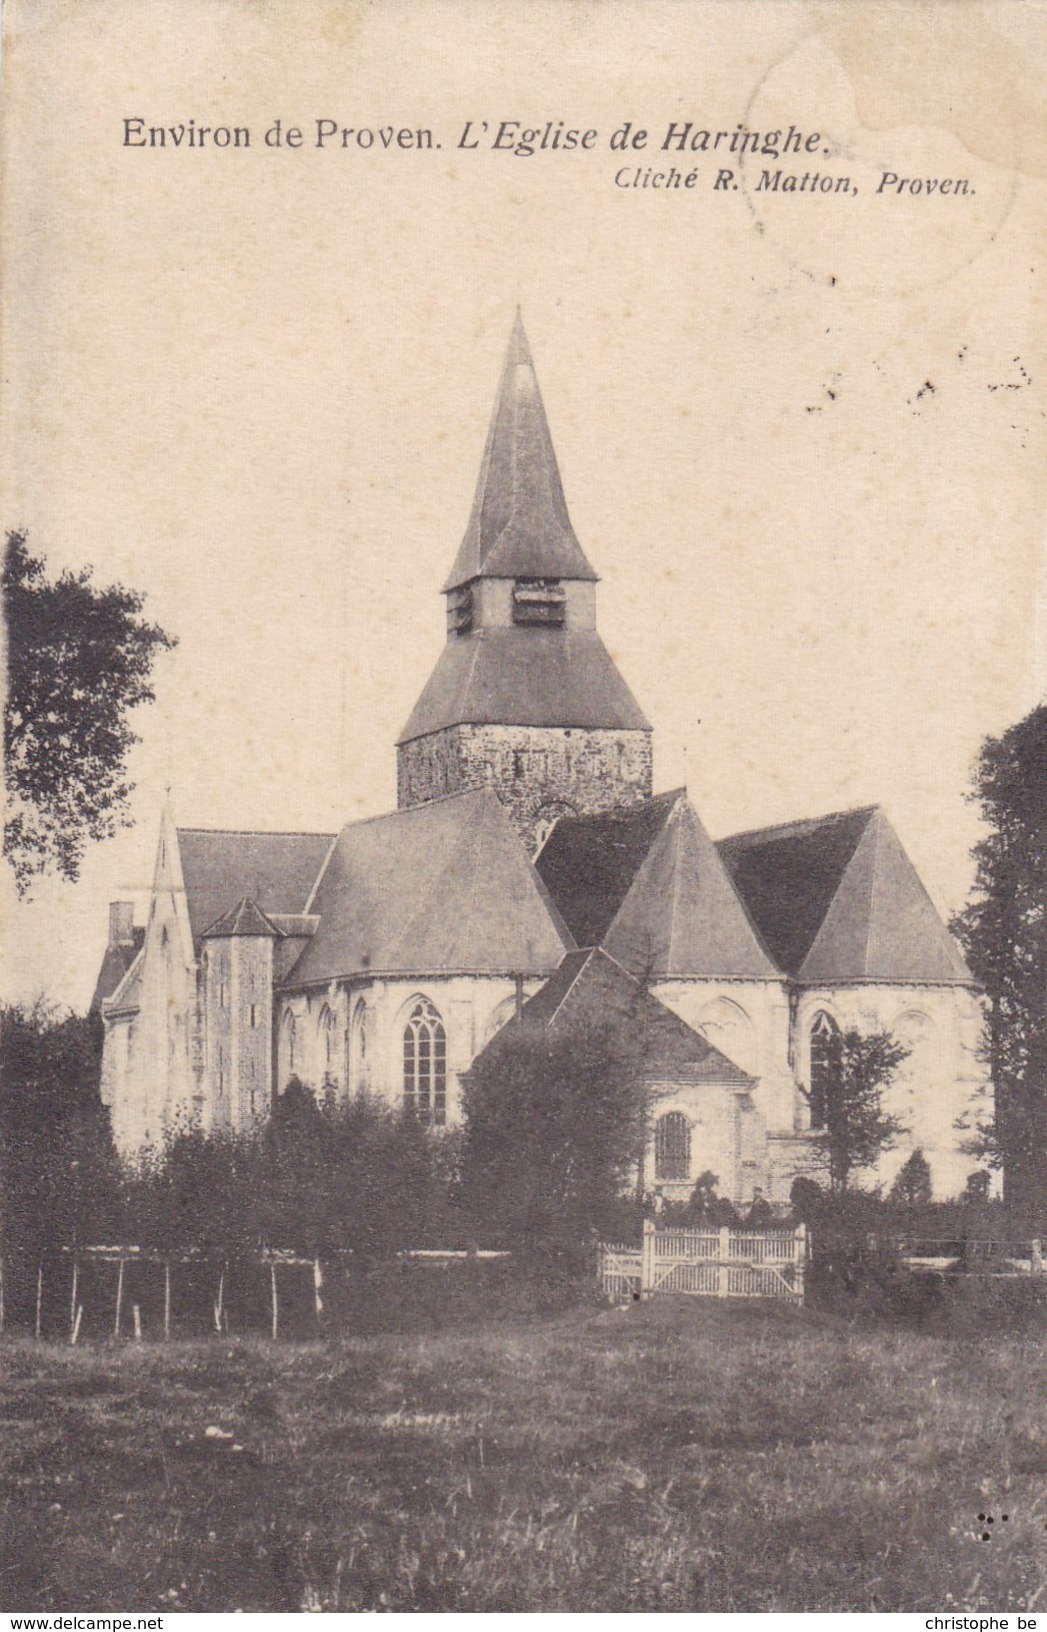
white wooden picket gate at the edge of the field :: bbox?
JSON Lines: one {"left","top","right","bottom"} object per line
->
{"left": 599, "top": 1219, "right": 807, "bottom": 1304}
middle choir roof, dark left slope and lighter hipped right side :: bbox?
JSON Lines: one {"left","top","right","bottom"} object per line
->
{"left": 537, "top": 790, "right": 780, "bottom": 981}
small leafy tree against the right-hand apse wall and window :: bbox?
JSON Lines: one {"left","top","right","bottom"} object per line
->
{"left": 807, "top": 1031, "right": 908, "bottom": 1193}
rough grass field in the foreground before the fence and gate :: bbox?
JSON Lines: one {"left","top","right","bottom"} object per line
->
{"left": 0, "top": 1299, "right": 1047, "bottom": 1612}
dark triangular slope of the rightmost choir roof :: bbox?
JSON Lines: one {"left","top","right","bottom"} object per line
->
{"left": 718, "top": 805, "right": 876, "bottom": 974}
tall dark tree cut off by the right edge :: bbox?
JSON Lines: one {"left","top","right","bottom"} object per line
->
{"left": 951, "top": 705, "right": 1047, "bottom": 1208}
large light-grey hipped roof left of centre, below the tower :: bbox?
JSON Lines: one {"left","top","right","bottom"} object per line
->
{"left": 280, "top": 790, "right": 571, "bottom": 986}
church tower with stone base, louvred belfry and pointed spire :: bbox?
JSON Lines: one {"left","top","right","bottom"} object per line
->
{"left": 396, "top": 317, "right": 652, "bottom": 855}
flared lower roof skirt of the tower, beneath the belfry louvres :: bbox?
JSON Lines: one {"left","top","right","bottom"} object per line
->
{"left": 398, "top": 627, "right": 651, "bottom": 743}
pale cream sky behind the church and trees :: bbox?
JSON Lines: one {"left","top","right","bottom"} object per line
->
{"left": 0, "top": 0, "right": 1047, "bottom": 1009}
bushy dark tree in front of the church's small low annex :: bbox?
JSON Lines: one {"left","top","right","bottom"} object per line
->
{"left": 462, "top": 1027, "right": 644, "bottom": 1247}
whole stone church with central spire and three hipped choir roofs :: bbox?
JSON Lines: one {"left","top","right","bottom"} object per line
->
{"left": 96, "top": 318, "right": 988, "bottom": 1204}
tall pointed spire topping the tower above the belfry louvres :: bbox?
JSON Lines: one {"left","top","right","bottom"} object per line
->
{"left": 444, "top": 312, "right": 597, "bottom": 591}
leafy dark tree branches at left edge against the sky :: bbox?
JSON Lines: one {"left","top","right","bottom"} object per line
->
{"left": 2, "top": 532, "right": 175, "bottom": 896}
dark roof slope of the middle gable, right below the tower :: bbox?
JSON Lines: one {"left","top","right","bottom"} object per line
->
{"left": 535, "top": 788, "right": 682, "bottom": 947}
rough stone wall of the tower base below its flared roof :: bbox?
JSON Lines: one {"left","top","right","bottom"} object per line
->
{"left": 396, "top": 725, "right": 652, "bottom": 855}
